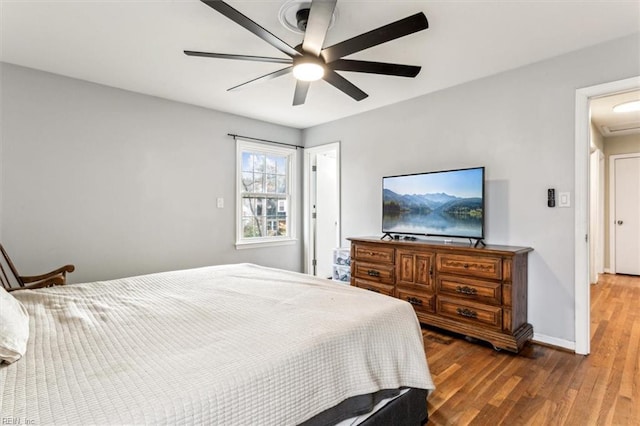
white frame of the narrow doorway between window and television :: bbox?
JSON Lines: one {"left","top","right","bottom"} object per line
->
{"left": 303, "top": 141, "right": 342, "bottom": 274}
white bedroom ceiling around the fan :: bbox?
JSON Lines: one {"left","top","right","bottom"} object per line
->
{"left": 0, "top": 0, "right": 640, "bottom": 128}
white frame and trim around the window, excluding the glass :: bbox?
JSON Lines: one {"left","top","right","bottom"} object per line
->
{"left": 236, "top": 139, "right": 298, "bottom": 249}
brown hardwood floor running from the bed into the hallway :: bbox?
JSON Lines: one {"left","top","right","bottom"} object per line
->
{"left": 423, "top": 275, "right": 640, "bottom": 426}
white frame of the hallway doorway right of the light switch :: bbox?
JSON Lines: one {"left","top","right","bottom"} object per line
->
{"left": 574, "top": 76, "right": 640, "bottom": 355}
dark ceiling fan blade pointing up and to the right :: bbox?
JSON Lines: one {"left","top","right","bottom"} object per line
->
{"left": 321, "top": 12, "right": 429, "bottom": 63}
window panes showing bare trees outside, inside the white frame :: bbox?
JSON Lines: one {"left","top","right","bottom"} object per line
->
{"left": 241, "top": 152, "right": 288, "bottom": 238}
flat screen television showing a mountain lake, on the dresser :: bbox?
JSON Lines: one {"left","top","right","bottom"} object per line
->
{"left": 382, "top": 167, "right": 484, "bottom": 240}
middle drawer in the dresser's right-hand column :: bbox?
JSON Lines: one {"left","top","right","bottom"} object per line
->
{"left": 436, "top": 275, "right": 502, "bottom": 305}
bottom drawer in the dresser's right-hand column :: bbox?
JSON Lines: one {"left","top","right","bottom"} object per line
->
{"left": 436, "top": 296, "right": 502, "bottom": 330}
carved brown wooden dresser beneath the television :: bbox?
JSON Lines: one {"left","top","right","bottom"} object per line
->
{"left": 349, "top": 238, "right": 533, "bottom": 352}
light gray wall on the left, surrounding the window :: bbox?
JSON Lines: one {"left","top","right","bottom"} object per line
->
{"left": 0, "top": 64, "right": 302, "bottom": 282}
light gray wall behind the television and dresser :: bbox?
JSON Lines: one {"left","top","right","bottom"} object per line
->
{"left": 304, "top": 34, "right": 640, "bottom": 344}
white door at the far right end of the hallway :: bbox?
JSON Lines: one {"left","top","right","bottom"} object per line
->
{"left": 613, "top": 155, "right": 640, "bottom": 275}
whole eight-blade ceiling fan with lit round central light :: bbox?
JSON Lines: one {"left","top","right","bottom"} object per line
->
{"left": 184, "top": 0, "right": 429, "bottom": 105}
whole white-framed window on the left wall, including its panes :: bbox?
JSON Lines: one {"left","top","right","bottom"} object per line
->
{"left": 236, "top": 140, "right": 296, "bottom": 248}
